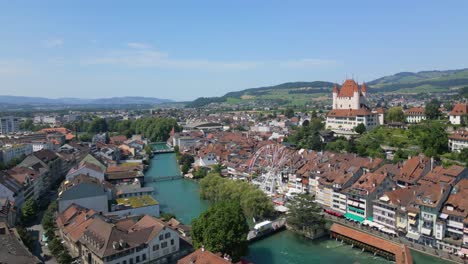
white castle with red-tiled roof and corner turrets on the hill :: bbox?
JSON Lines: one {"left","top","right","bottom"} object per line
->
{"left": 326, "top": 80, "right": 383, "bottom": 135}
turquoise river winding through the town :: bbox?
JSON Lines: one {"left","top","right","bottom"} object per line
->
{"left": 145, "top": 153, "right": 447, "bottom": 264}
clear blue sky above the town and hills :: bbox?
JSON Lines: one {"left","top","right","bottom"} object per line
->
{"left": 0, "top": 0, "right": 468, "bottom": 100}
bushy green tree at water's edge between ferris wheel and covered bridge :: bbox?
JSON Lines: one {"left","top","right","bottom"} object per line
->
{"left": 287, "top": 194, "right": 325, "bottom": 236}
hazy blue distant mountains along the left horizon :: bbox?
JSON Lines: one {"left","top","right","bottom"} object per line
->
{"left": 0, "top": 95, "right": 173, "bottom": 105}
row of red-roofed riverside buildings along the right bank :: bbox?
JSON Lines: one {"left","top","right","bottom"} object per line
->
{"left": 296, "top": 152, "right": 468, "bottom": 255}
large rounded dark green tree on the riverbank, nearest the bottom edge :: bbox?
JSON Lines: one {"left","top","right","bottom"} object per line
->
{"left": 192, "top": 201, "right": 249, "bottom": 262}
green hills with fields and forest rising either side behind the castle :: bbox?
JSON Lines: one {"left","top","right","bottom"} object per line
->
{"left": 187, "top": 68, "right": 468, "bottom": 107}
